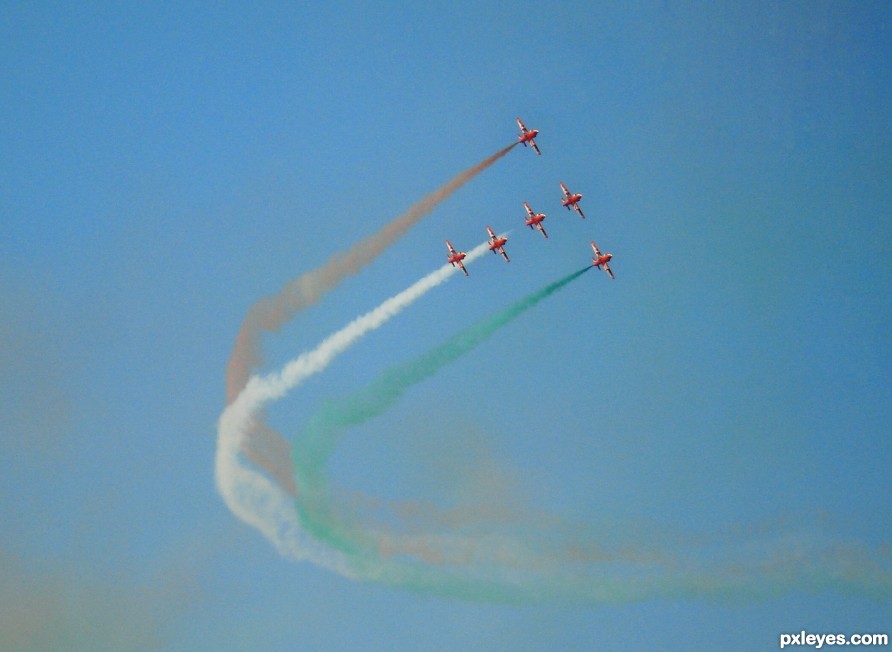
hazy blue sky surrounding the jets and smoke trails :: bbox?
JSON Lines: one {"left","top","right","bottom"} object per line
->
{"left": 0, "top": 2, "right": 892, "bottom": 650}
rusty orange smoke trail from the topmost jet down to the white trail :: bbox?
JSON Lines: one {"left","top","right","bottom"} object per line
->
{"left": 226, "top": 143, "right": 517, "bottom": 404}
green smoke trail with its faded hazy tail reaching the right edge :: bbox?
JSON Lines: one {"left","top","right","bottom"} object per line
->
{"left": 292, "top": 267, "right": 892, "bottom": 604}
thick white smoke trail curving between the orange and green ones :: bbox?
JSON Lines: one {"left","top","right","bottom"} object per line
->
{"left": 215, "top": 243, "right": 489, "bottom": 564}
